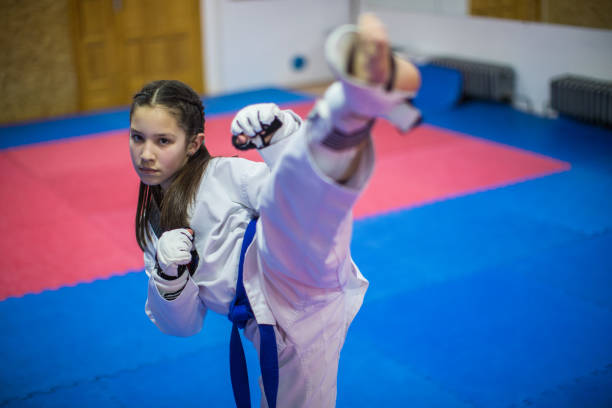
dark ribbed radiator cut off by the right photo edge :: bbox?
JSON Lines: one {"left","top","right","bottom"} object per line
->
{"left": 550, "top": 75, "right": 612, "bottom": 126}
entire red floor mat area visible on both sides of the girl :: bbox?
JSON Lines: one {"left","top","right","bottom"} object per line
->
{"left": 0, "top": 103, "right": 569, "bottom": 300}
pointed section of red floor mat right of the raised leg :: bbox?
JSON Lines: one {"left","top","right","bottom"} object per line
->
{"left": 355, "top": 121, "right": 570, "bottom": 217}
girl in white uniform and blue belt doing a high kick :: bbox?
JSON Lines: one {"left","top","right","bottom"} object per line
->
{"left": 130, "top": 15, "right": 420, "bottom": 408}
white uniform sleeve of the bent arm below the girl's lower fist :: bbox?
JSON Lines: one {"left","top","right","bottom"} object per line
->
{"left": 144, "top": 241, "right": 207, "bottom": 337}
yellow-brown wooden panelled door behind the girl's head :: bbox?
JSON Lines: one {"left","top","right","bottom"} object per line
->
{"left": 73, "top": 0, "right": 204, "bottom": 110}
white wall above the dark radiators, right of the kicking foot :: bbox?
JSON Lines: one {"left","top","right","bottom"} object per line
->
{"left": 361, "top": 0, "right": 612, "bottom": 113}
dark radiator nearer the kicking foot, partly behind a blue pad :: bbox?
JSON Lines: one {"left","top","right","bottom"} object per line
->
{"left": 429, "top": 57, "right": 514, "bottom": 102}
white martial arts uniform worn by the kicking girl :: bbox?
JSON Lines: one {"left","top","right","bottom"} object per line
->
{"left": 145, "top": 110, "right": 374, "bottom": 408}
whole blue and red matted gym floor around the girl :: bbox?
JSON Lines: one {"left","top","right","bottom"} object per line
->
{"left": 0, "top": 67, "right": 612, "bottom": 408}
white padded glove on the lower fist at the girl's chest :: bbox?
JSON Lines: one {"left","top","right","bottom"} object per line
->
{"left": 157, "top": 228, "right": 193, "bottom": 277}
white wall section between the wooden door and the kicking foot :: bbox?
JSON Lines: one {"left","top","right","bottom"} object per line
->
{"left": 200, "top": 0, "right": 350, "bottom": 94}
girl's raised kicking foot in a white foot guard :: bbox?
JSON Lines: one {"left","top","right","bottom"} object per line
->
{"left": 315, "top": 14, "right": 421, "bottom": 139}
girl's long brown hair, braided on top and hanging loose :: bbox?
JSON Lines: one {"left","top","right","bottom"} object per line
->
{"left": 130, "top": 80, "right": 211, "bottom": 251}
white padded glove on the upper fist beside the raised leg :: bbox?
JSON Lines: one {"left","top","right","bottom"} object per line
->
{"left": 231, "top": 103, "right": 301, "bottom": 150}
